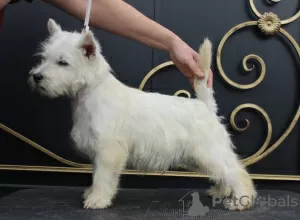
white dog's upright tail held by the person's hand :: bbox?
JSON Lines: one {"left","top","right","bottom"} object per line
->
{"left": 194, "top": 38, "right": 218, "bottom": 113}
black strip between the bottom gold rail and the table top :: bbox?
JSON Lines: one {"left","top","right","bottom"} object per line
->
{"left": 0, "top": 176, "right": 300, "bottom": 198}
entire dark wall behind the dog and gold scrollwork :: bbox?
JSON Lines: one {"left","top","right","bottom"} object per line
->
{"left": 0, "top": 0, "right": 300, "bottom": 185}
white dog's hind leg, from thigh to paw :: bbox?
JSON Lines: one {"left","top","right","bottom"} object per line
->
{"left": 193, "top": 146, "right": 256, "bottom": 210}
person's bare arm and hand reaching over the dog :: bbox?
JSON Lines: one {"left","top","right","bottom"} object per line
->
{"left": 44, "top": 0, "right": 212, "bottom": 85}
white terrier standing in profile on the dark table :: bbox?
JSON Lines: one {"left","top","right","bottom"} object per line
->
{"left": 29, "top": 19, "right": 256, "bottom": 210}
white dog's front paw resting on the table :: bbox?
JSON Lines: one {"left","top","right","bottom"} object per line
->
{"left": 84, "top": 190, "right": 111, "bottom": 209}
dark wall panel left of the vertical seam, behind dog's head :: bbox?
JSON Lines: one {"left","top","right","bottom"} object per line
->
{"left": 0, "top": 0, "right": 154, "bottom": 165}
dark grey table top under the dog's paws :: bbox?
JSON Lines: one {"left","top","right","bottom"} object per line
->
{"left": 0, "top": 187, "right": 300, "bottom": 220}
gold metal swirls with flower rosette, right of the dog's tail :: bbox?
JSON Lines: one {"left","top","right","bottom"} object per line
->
{"left": 217, "top": 0, "right": 300, "bottom": 166}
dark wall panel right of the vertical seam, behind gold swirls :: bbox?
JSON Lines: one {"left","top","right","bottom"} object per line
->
{"left": 152, "top": 0, "right": 300, "bottom": 174}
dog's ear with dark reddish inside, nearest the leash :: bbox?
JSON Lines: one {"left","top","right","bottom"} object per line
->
{"left": 79, "top": 31, "right": 97, "bottom": 58}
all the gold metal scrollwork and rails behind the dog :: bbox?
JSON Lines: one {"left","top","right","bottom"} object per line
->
{"left": 0, "top": 0, "right": 300, "bottom": 181}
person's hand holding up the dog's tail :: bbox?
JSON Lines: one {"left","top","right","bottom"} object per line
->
{"left": 169, "top": 39, "right": 213, "bottom": 88}
